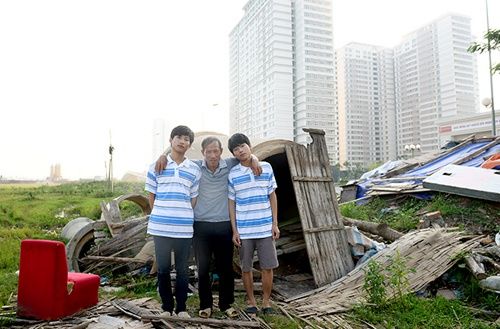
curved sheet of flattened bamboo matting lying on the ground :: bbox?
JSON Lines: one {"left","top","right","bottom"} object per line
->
{"left": 285, "top": 229, "right": 481, "bottom": 325}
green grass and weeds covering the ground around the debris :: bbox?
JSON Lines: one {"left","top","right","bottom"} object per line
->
{"left": 0, "top": 182, "right": 500, "bottom": 328}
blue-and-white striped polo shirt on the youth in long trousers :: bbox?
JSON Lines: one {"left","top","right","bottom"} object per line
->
{"left": 146, "top": 155, "right": 201, "bottom": 238}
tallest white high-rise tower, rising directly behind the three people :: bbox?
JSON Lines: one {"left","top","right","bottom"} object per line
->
{"left": 230, "top": 0, "right": 338, "bottom": 163}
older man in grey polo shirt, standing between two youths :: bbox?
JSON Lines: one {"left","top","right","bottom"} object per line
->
{"left": 156, "top": 137, "right": 262, "bottom": 318}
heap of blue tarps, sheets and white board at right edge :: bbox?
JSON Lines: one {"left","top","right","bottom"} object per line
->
{"left": 341, "top": 137, "right": 500, "bottom": 203}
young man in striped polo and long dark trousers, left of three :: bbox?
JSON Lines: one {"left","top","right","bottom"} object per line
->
{"left": 146, "top": 126, "right": 201, "bottom": 317}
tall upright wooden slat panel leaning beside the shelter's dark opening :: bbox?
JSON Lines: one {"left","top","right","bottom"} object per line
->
{"left": 286, "top": 130, "right": 354, "bottom": 286}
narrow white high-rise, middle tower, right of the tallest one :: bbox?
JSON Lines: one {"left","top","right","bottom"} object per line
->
{"left": 336, "top": 43, "right": 396, "bottom": 166}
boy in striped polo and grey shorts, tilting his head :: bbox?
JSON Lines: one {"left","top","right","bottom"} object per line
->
{"left": 228, "top": 133, "right": 280, "bottom": 314}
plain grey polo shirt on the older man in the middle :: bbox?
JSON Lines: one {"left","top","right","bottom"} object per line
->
{"left": 193, "top": 158, "right": 239, "bottom": 222}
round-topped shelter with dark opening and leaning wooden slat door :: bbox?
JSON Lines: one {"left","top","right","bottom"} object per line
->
{"left": 252, "top": 129, "right": 354, "bottom": 286}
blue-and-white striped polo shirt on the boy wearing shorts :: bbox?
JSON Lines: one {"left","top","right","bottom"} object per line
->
{"left": 228, "top": 162, "right": 278, "bottom": 239}
